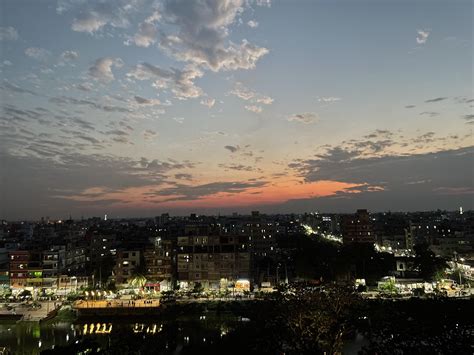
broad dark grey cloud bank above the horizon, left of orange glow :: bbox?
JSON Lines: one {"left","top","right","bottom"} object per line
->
{"left": 0, "top": 148, "right": 194, "bottom": 219}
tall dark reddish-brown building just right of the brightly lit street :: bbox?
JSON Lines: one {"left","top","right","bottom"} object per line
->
{"left": 341, "top": 210, "right": 375, "bottom": 244}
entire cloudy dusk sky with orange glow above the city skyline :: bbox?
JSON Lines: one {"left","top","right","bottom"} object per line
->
{"left": 0, "top": 0, "right": 474, "bottom": 219}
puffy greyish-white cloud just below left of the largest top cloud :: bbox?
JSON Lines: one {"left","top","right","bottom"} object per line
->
{"left": 127, "top": 63, "right": 203, "bottom": 99}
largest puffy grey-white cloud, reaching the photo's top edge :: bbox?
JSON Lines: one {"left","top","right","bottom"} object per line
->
{"left": 159, "top": 0, "right": 268, "bottom": 72}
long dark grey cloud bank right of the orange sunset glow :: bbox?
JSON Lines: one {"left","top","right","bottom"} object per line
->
{"left": 282, "top": 146, "right": 474, "bottom": 211}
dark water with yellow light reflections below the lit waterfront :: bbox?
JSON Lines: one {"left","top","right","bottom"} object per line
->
{"left": 0, "top": 314, "right": 248, "bottom": 355}
